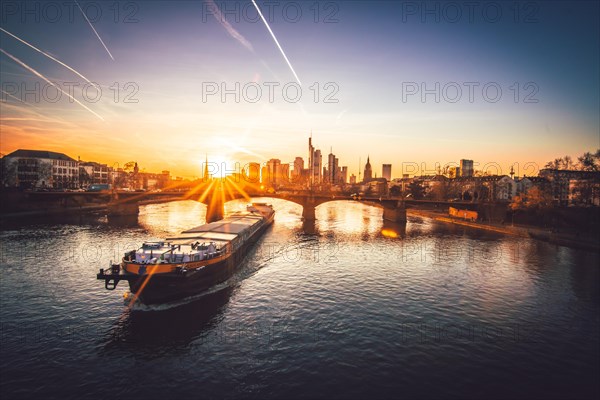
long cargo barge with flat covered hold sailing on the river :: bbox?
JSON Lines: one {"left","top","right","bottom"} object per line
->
{"left": 96, "top": 203, "right": 275, "bottom": 304}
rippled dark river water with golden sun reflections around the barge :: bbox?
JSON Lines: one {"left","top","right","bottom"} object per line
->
{"left": 0, "top": 200, "right": 600, "bottom": 399}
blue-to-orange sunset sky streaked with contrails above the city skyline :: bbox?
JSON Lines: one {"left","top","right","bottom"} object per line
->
{"left": 0, "top": 0, "right": 600, "bottom": 177}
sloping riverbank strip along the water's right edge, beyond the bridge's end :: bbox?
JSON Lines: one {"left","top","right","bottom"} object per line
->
{"left": 406, "top": 209, "right": 600, "bottom": 252}
